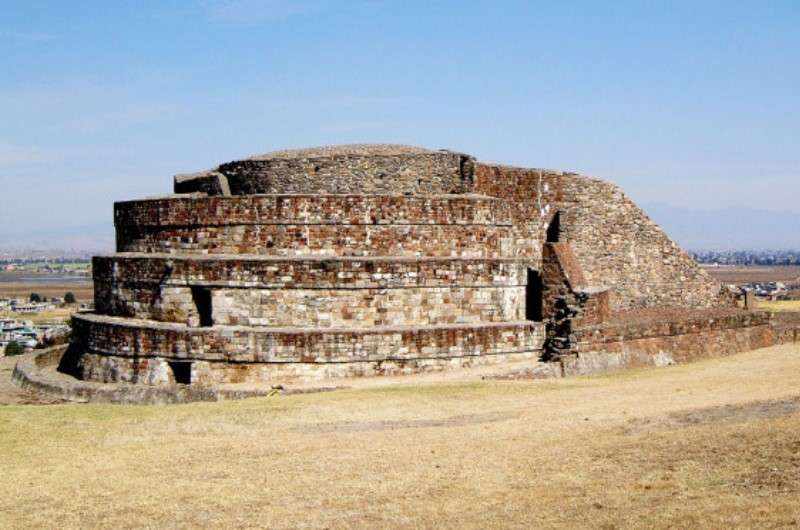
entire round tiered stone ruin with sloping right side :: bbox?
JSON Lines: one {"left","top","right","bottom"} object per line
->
{"left": 61, "top": 145, "right": 775, "bottom": 385}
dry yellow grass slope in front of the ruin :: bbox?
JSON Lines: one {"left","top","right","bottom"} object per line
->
{"left": 0, "top": 346, "right": 800, "bottom": 528}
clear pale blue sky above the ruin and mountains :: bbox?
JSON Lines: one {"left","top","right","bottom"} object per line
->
{"left": 0, "top": 0, "right": 800, "bottom": 237}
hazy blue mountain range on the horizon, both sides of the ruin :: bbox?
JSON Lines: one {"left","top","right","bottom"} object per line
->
{"left": 0, "top": 203, "right": 800, "bottom": 252}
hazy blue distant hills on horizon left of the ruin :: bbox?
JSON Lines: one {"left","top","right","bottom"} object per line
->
{"left": 0, "top": 223, "right": 114, "bottom": 252}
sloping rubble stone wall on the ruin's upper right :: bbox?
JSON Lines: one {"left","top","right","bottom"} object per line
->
{"left": 473, "top": 164, "right": 731, "bottom": 309}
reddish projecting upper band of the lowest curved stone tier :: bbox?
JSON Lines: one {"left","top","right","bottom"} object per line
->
{"left": 73, "top": 313, "right": 543, "bottom": 363}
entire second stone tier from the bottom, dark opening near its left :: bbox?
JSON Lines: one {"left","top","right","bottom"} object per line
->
{"left": 93, "top": 254, "right": 527, "bottom": 328}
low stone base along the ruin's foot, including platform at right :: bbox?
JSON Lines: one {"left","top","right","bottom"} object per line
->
{"left": 13, "top": 309, "right": 800, "bottom": 404}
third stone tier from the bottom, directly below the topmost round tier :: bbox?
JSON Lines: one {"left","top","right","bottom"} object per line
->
{"left": 115, "top": 195, "right": 524, "bottom": 257}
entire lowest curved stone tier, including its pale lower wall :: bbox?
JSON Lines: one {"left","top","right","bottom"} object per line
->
{"left": 72, "top": 314, "right": 544, "bottom": 384}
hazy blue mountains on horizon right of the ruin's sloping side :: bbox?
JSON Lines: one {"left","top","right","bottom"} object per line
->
{"left": 643, "top": 203, "right": 800, "bottom": 250}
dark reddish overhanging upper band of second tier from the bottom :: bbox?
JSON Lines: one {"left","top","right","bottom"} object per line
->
{"left": 92, "top": 253, "right": 527, "bottom": 289}
